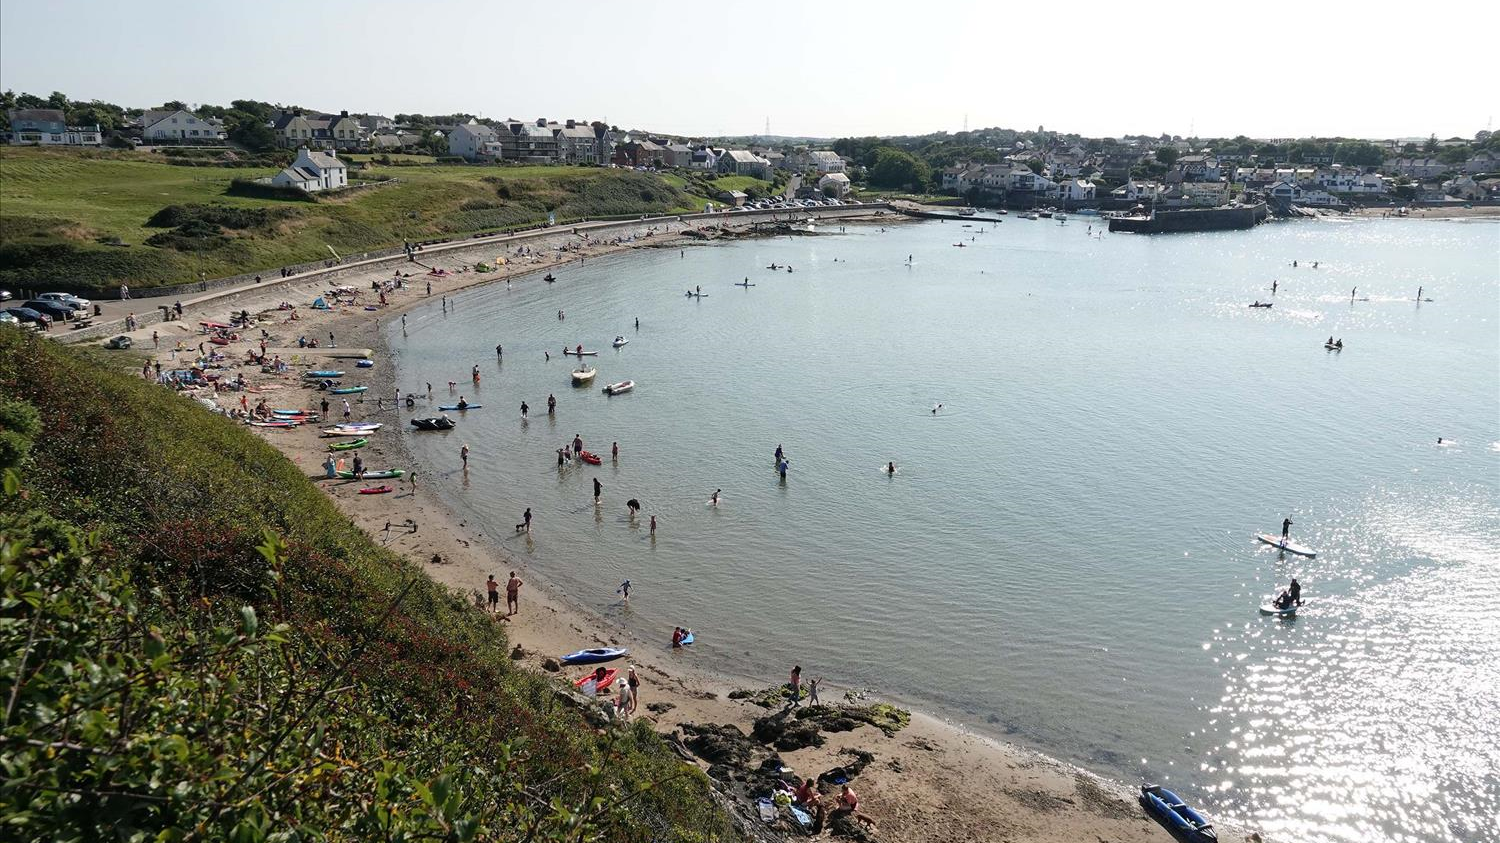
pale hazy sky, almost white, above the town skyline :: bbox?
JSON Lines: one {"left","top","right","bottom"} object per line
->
{"left": 0, "top": 0, "right": 1500, "bottom": 138}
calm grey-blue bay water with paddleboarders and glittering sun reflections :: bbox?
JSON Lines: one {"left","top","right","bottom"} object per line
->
{"left": 390, "top": 218, "right": 1500, "bottom": 842}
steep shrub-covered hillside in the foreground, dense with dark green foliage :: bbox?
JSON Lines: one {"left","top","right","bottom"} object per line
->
{"left": 0, "top": 327, "right": 737, "bottom": 843}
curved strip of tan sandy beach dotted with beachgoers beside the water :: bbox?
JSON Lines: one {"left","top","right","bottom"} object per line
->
{"left": 90, "top": 212, "right": 1259, "bottom": 843}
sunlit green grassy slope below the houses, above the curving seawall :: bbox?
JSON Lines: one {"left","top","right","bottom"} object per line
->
{"left": 0, "top": 147, "right": 707, "bottom": 290}
